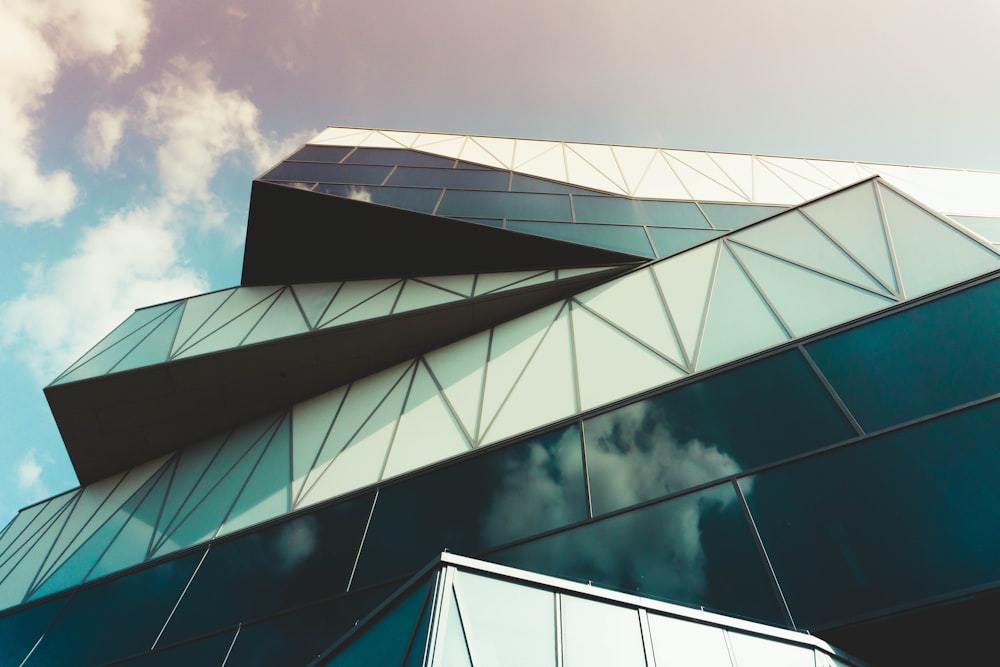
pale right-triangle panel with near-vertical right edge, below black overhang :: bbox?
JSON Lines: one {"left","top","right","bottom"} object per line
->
{"left": 483, "top": 304, "right": 578, "bottom": 442}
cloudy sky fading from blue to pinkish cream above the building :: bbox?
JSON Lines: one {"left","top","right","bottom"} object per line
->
{"left": 0, "top": 0, "right": 1000, "bottom": 527}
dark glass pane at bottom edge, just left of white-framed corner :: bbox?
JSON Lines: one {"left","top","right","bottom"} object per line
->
{"left": 226, "top": 584, "right": 399, "bottom": 667}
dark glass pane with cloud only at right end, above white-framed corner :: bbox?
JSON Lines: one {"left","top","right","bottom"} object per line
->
{"left": 352, "top": 426, "right": 587, "bottom": 586}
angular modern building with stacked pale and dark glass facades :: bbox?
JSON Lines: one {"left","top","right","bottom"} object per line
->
{"left": 0, "top": 128, "right": 1000, "bottom": 667}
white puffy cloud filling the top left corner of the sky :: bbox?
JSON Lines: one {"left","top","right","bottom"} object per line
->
{"left": 0, "top": 0, "right": 149, "bottom": 224}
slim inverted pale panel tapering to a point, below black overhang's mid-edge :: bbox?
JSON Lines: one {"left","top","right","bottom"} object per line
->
{"left": 479, "top": 303, "right": 562, "bottom": 439}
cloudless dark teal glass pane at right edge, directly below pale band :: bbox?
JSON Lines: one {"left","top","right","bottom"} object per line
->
{"left": 806, "top": 280, "right": 1000, "bottom": 431}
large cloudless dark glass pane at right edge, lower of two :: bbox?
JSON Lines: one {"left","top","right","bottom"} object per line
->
{"left": 741, "top": 402, "right": 1000, "bottom": 628}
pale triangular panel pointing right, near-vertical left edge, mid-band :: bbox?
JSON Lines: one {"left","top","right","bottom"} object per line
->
{"left": 573, "top": 305, "right": 684, "bottom": 410}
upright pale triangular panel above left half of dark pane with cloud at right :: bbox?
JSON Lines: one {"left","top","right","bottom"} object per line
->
{"left": 382, "top": 364, "right": 472, "bottom": 478}
